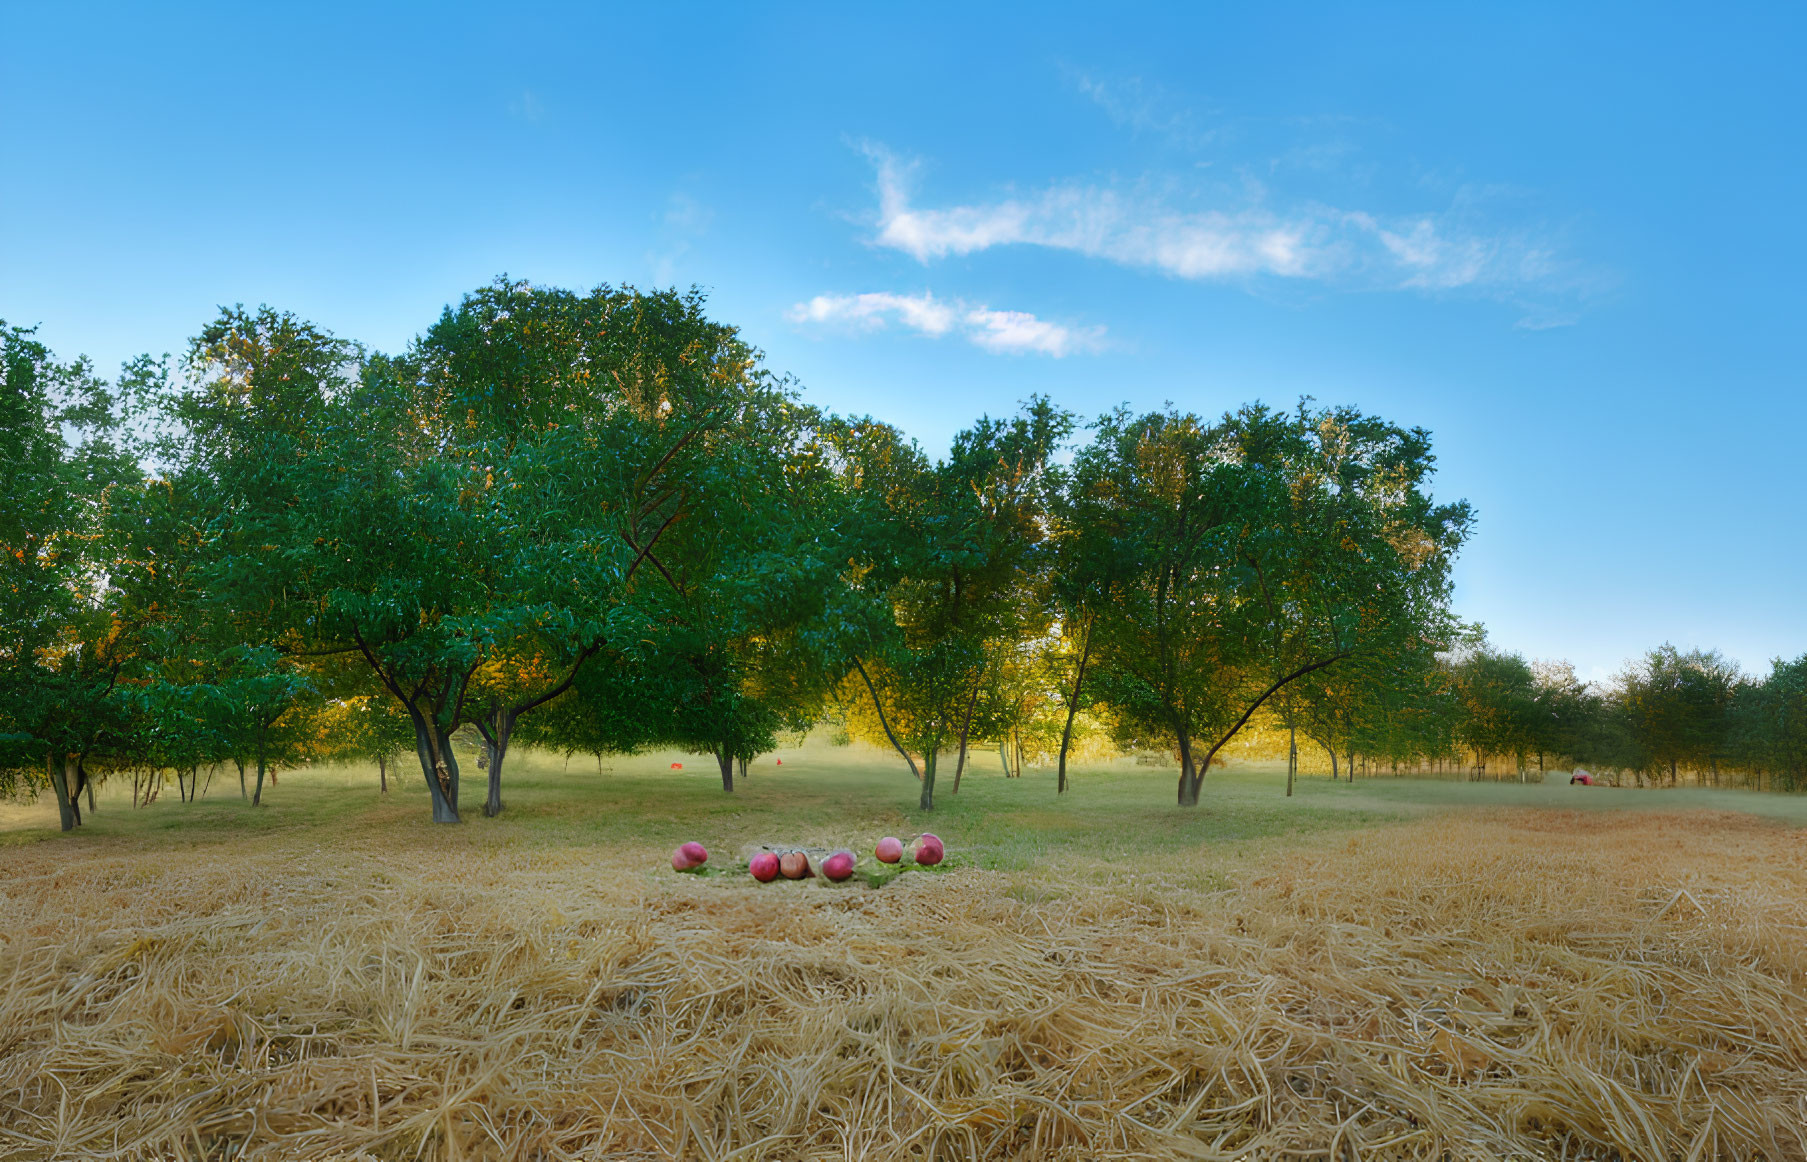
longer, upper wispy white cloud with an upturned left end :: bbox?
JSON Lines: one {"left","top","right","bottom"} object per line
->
{"left": 864, "top": 145, "right": 1582, "bottom": 305}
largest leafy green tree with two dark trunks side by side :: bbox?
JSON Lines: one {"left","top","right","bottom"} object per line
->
{"left": 177, "top": 282, "right": 784, "bottom": 822}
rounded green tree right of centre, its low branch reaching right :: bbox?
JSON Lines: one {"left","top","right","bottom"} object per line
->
{"left": 1072, "top": 405, "right": 1469, "bottom": 806}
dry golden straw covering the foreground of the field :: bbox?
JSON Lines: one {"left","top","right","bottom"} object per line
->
{"left": 0, "top": 813, "right": 1807, "bottom": 1160}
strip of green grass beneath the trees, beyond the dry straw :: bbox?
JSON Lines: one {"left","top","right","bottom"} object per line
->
{"left": 0, "top": 741, "right": 1807, "bottom": 863}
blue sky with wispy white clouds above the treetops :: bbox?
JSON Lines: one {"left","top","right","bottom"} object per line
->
{"left": 0, "top": 4, "right": 1807, "bottom": 676}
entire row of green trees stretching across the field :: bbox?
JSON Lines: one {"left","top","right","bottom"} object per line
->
{"left": 0, "top": 280, "right": 1807, "bottom": 829}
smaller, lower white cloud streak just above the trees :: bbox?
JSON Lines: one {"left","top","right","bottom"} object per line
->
{"left": 790, "top": 291, "right": 1104, "bottom": 360}
